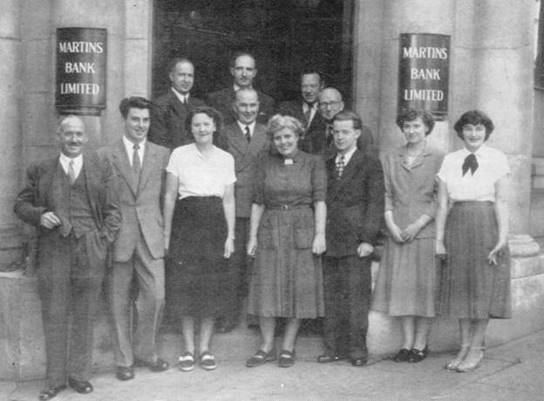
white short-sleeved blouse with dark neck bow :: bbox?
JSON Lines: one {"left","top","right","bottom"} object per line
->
{"left": 438, "top": 145, "right": 510, "bottom": 202}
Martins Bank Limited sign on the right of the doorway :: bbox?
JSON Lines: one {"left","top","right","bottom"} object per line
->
{"left": 398, "top": 33, "right": 450, "bottom": 119}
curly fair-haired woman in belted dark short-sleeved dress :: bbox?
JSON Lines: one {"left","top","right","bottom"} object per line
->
{"left": 246, "top": 115, "right": 327, "bottom": 367}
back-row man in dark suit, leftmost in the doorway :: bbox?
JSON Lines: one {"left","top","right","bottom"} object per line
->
{"left": 148, "top": 57, "right": 204, "bottom": 149}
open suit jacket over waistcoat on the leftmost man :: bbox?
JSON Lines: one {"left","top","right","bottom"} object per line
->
{"left": 14, "top": 152, "right": 121, "bottom": 258}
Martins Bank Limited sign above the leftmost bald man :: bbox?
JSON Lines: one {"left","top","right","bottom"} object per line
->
{"left": 55, "top": 28, "right": 107, "bottom": 115}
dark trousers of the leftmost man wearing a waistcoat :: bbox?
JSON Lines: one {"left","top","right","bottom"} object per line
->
{"left": 37, "top": 231, "right": 106, "bottom": 386}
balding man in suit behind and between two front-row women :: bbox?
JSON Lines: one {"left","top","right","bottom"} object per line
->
{"left": 217, "top": 88, "right": 269, "bottom": 332}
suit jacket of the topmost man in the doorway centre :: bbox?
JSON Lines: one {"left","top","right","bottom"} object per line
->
{"left": 206, "top": 86, "right": 274, "bottom": 126}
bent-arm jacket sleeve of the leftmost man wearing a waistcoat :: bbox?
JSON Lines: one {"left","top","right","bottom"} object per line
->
{"left": 14, "top": 165, "right": 47, "bottom": 227}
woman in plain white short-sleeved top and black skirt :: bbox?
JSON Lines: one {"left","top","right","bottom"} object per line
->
{"left": 164, "top": 107, "right": 236, "bottom": 371}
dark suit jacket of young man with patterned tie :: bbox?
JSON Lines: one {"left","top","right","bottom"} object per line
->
{"left": 326, "top": 150, "right": 385, "bottom": 257}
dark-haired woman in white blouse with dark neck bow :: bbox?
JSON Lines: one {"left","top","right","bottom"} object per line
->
{"left": 436, "top": 110, "right": 511, "bottom": 372}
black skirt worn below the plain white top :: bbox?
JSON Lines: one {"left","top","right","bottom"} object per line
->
{"left": 166, "top": 197, "right": 236, "bottom": 317}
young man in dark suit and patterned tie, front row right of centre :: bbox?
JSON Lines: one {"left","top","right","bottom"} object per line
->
{"left": 317, "top": 111, "right": 385, "bottom": 366}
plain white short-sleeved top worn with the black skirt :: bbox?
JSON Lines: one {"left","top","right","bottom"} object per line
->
{"left": 166, "top": 143, "right": 236, "bottom": 199}
